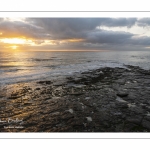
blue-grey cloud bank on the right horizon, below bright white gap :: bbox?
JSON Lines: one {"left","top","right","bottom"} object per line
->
{"left": 63, "top": 30, "right": 150, "bottom": 50}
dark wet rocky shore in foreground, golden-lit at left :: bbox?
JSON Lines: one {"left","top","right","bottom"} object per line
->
{"left": 0, "top": 65, "right": 150, "bottom": 132}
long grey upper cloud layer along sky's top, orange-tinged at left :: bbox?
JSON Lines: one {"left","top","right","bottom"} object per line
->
{"left": 0, "top": 18, "right": 148, "bottom": 40}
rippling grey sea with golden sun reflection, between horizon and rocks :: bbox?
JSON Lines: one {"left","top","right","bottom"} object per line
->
{"left": 0, "top": 50, "right": 150, "bottom": 86}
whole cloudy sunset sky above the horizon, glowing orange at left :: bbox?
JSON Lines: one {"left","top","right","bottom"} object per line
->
{"left": 0, "top": 18, "right": 150, "bottom": 51}
